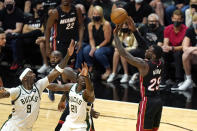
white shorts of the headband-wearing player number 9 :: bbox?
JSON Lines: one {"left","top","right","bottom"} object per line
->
{"left": 0, "top": 120, "right": 32, "bottom": 131}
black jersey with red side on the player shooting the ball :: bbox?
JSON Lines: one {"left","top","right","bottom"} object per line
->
{"left": 140, "top": 61, "right": 163, "bottom": 98}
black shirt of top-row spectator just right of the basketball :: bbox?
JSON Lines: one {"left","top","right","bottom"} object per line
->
{"left": 124, "top": 2, "right": 154, "bottom": 23}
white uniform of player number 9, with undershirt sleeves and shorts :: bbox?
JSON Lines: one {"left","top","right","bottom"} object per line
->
{"left": 1, "top": 77, "right": 49, "bottom": 131}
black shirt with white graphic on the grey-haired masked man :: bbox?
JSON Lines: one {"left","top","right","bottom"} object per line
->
{"left": 139, "top": 25, "right": 164, "bottom": 45}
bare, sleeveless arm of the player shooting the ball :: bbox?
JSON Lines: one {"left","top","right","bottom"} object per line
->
{"left": 114, "top": 25, "right": 148, "bottom": 76}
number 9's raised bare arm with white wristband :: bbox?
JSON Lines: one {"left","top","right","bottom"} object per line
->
{"left": 47, "top": 40, "right": 75, "bottom": 83}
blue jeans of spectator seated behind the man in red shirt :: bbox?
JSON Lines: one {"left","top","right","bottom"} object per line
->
{"left": 165, "top": 5, "right": 189, "bottom": 25}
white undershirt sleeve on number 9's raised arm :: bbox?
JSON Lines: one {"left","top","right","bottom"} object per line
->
{"left": 35, "top": 77, "right": 49, "bottom": 95}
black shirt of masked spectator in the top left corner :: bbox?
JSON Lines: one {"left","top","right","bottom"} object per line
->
{"left": 0, "top": 7, "right": 24, "bottom": 30}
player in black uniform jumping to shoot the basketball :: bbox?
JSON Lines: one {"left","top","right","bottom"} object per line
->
{"left": 114, "top": 17, "right": 163, "bottom": 131}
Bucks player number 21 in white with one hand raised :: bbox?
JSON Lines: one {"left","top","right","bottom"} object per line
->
{"left": 48, "top": 63, "right": 95, "bottom": 131}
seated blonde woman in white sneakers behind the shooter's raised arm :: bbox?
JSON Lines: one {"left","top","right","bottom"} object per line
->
{"left": 107, "top": 23, "right": 137, "bottom": 83}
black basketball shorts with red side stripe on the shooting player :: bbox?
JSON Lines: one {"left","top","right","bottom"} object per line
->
{"left": 136, "top": 96, "right": 162, "bottom": 131}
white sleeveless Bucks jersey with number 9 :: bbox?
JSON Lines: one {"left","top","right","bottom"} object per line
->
{"left": 11, "top": 86, "right": 41, "bottom": 128}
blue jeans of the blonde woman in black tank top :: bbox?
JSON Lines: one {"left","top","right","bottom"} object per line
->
{"left": 83, "top": 45, "right": 113, "bottom": 69}
